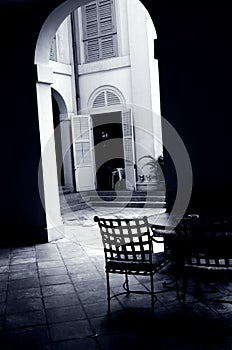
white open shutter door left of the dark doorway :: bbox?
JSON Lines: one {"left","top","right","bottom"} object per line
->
{"left": 71, "top": 115, "right": 95, "bottom": 191}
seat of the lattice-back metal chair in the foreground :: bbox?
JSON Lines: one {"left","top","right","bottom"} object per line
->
{"left": 106, "top": 252, "right": 169, "bottom": 275}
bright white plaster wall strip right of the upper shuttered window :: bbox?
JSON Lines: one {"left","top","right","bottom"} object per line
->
{"left": 127, "top": 1, "right": 160, "bottom": 170}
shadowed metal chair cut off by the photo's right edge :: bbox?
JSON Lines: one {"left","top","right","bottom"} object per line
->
{"left": 179, "top": 220, "right": 232, "bottom": 306}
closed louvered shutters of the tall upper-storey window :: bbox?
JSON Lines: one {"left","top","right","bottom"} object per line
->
{"left": 82, "top": 0, "right": 117, "bottom": 62}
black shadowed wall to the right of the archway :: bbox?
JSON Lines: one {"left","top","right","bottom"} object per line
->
{"left": 148, "top": 2, "right": 232, "bottom": 216}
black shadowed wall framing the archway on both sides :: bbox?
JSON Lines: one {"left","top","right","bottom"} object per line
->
{"left": 0, "top": 0, "right": 232, "bottom": 243}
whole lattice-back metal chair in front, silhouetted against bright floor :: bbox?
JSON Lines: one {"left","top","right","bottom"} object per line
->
{"left": 94, "top": 216, "right": 167, "bottom": 316}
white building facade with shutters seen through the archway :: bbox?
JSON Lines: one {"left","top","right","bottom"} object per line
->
{"left": 49, "top": 0, "right": 163, "bottom": 192}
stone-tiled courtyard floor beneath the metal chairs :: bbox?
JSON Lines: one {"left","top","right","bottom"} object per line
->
{"left": 0, "top": 206, "right": 232, "bottom": 350}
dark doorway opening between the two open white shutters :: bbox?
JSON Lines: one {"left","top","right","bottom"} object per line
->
{"left": 92, "top": 112, "right": 124, "bottom": 191}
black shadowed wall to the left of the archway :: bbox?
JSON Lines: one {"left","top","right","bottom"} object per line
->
{"left": 0, "top": 0, "right": 64, "bottom": 243}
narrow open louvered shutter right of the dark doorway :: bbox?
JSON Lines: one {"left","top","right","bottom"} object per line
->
{"left": 122, "top": 110, "right": 135, "bottom": 190}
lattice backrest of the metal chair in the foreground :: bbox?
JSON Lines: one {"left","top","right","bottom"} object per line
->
{"left": 95, "top": 217, "right": 153, "bottom": 274}
